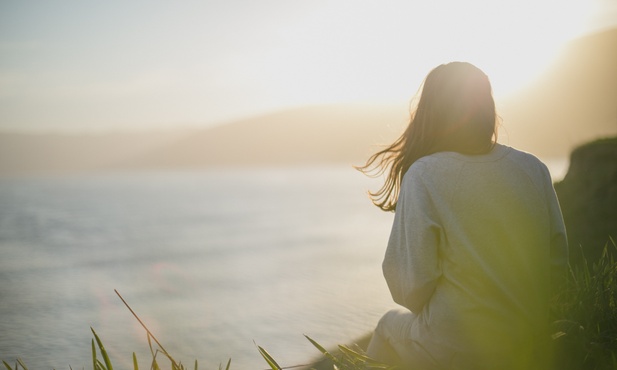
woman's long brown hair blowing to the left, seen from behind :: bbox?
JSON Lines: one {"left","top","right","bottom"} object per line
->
{"left": 357, "top": 62, "right": 497, "bottom": 211}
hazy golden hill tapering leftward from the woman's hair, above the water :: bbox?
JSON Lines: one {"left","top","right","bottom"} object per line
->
{"left": 118, "top": 105, "right": 408, "bottom": 168}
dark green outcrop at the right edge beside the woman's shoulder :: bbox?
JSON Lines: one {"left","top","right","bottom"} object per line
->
{"left": 555, "top": 137, "right": 617, "bottom": 266}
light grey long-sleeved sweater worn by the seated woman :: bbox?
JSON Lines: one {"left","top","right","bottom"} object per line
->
{"left": 383, "top": 144, "right": 568, "bottom": 368}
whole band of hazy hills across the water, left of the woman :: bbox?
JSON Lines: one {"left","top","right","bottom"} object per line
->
{"left": 0, "top": 104, "right": 408, "bottom": 175}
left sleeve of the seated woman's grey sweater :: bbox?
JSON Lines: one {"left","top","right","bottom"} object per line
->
{"left": 382, "top": 166, "right": 442, "bottom": 313}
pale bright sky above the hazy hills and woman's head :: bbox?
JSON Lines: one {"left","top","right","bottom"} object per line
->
{"left": 0, "top": 0, "right": 617, "bottom": 132}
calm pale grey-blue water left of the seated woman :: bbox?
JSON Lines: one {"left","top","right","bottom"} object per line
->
{"left": 0, "top": 167, "right": 392, "bottom": 369}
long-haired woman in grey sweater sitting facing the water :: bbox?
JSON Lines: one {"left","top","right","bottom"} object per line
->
{"left": 360, "top": 62, "right": 567, "bottom": 370}
